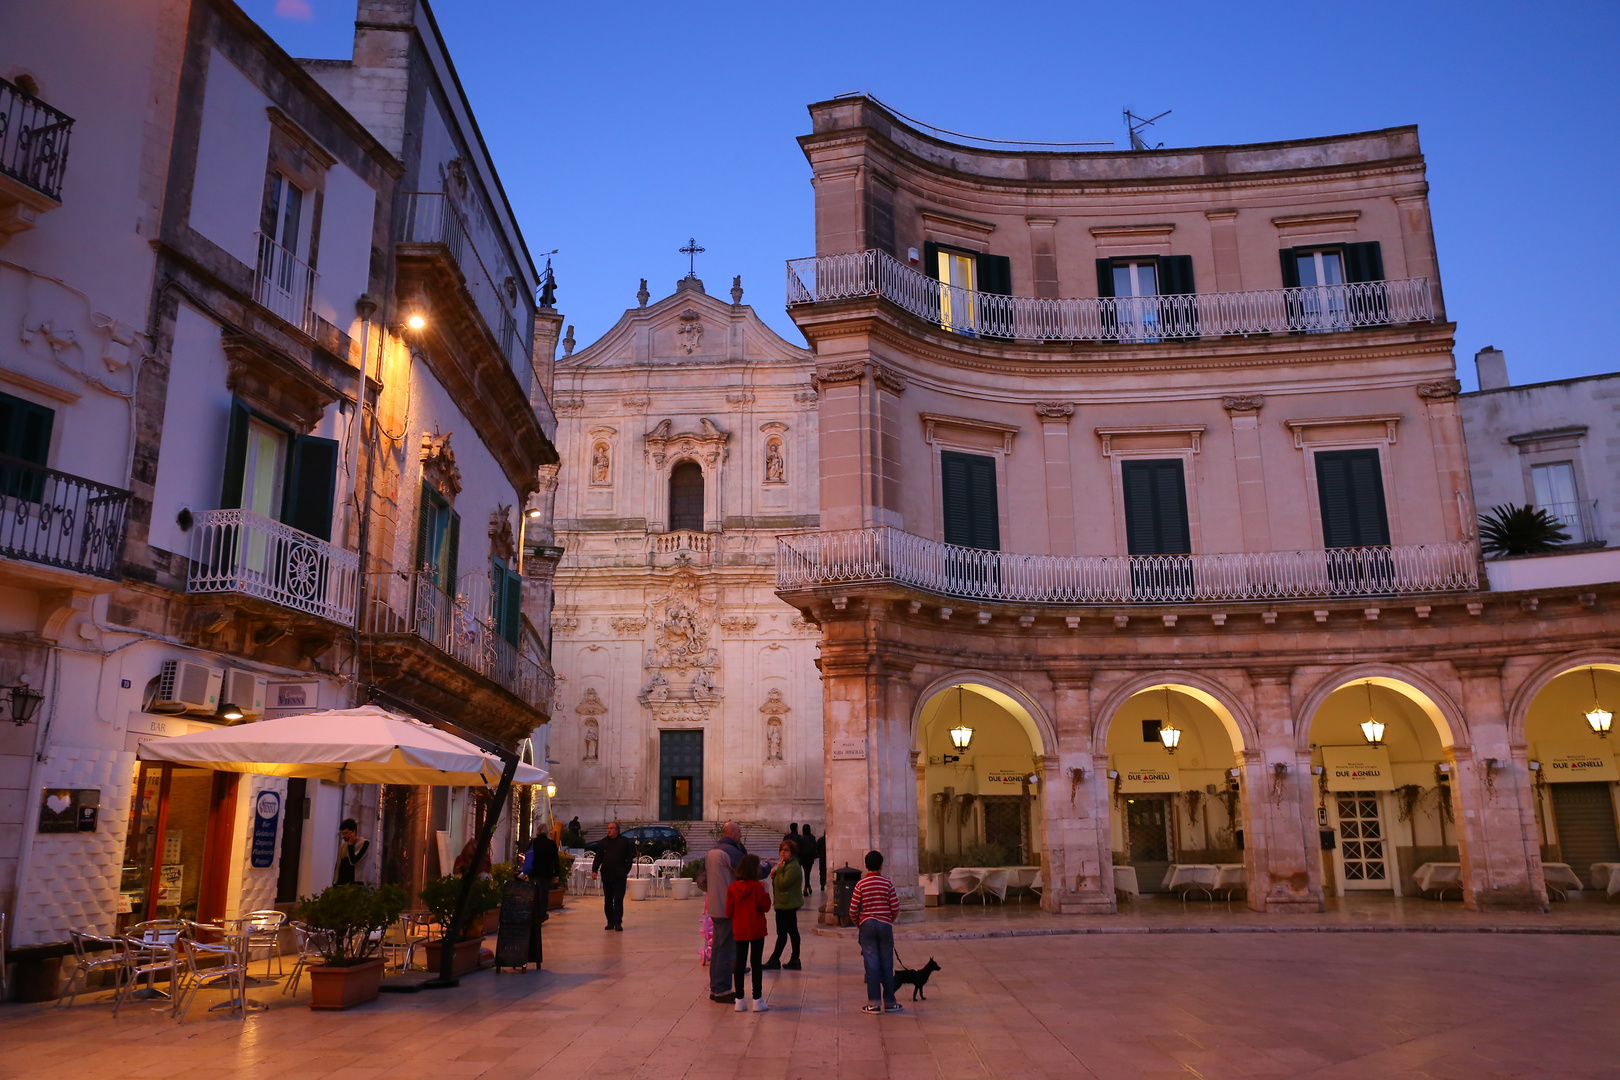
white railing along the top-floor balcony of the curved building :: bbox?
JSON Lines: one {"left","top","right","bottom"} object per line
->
{"left": 787, "top": 251, "right": 1435, "bottom": 342}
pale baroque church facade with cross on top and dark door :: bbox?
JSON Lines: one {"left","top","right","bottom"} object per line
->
{"left": 549, "top": 275, "right": 823, "bottom": 827}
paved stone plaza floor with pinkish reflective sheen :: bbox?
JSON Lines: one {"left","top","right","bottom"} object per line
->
{"left": 0, "top": 900, "right": 1620, "bottom": 1080}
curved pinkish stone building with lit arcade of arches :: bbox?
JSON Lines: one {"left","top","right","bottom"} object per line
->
{"left": 776, "top": 96, "right": 1620, "bottom": 912}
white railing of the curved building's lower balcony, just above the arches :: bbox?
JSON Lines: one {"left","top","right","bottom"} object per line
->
{"left": 776, "top": 528, "right": 1479, "bottom": 604}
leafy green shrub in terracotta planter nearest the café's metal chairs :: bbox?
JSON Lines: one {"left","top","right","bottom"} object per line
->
{"left": 298, "top": 882, "right": 405, "bottom": 1009}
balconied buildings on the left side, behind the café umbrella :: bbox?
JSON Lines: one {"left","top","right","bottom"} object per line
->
{"left": 0, "top": 0, "right": 561, "bottom": 946}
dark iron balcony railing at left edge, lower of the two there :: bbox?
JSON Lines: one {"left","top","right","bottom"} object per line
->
{"left": 0, "top": 455, "right": 130, "bottom": 580}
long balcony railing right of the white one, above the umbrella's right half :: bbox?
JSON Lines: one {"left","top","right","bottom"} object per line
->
{"left": 361, "top": 570, "right": 552, "bottom": 709}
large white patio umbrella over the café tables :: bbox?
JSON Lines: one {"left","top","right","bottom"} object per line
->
{"left": 138, "top": 704, "right": 551, "bottom": 787}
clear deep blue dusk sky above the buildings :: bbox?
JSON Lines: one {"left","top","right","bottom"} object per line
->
{"left": 245, "top": 0, "right": 1620, "bottom": 389}
